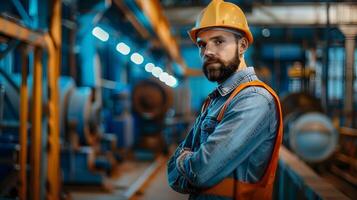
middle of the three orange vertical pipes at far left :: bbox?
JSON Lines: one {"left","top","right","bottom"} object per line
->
{"left": 26, "top": 48, "right": 42, "bottom": 199}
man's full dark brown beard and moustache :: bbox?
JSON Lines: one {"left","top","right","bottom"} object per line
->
{"left": 202, "top": 50, "right": 240, "bottom": 83}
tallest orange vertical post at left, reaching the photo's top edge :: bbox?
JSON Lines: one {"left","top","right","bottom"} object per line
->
{"left": 46, "top": 0, "right": 61, "bottom": 200}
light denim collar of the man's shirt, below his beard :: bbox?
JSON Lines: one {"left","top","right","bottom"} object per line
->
{"left": 217, "top": 67, "right": 258, "bottom": 96}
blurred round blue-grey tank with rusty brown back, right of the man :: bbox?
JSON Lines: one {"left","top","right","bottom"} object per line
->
{"left": 282, "top": 93, "right": 338, "bottom": 163}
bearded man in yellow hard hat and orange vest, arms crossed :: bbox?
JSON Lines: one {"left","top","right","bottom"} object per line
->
{"left": 167, "top": 0, "right": 282, "bottom": 200}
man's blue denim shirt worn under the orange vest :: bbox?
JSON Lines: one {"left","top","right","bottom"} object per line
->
{"left": 167, "top": 67, "right": 278, "bottom": 199}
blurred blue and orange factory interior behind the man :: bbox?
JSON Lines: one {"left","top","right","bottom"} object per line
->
{"left": 0, "top": 0, "right": 357, "bottom": 200}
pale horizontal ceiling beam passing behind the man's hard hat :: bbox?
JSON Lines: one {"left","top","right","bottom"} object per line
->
{"left": 165, "top": 3, "right": 357, "bottom": 26}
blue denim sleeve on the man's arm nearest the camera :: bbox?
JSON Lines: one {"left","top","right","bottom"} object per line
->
{"left": 176, "top": 92, "right": 275, "bottom": 188}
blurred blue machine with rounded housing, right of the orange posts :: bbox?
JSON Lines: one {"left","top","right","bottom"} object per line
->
{"left": 59, "top": 77, "right": 116, "bottom": 184}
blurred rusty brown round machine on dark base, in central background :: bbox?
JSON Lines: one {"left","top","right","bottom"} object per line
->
{"left": 132, "top": 80, "right": 173, "bottom": 152}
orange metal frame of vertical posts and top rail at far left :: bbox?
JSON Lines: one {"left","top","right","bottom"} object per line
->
{"left": 0, "top": 0, "right": 61, "bottom": 200}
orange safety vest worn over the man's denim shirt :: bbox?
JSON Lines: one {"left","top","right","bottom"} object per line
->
{"left": 201, "top": 81, "right": 283, "bottom": 200}
